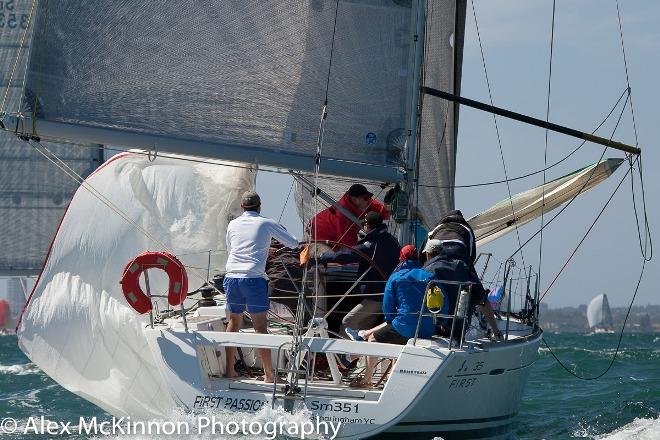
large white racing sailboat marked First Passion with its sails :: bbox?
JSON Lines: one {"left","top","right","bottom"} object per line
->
{"left": 3, "top": 0, "right": 635, "bottom": 438}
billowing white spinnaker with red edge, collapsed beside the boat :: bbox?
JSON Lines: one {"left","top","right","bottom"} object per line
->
{"left": 18, "top": 153, "right": 255, "bottom": 418}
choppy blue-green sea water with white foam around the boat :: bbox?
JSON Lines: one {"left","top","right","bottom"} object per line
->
{"left": 0, "top": 333, "right": 660, "bottom": 440}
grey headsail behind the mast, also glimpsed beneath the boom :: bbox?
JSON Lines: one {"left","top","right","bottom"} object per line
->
{"left": 296, "top": 0, "right": 466, "bottom": 234}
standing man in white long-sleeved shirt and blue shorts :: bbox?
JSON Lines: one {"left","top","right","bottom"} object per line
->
{"left": 223, "top": 191, "right": 298, "bottom": 383}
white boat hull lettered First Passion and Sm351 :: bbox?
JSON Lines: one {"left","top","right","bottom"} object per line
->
{"left": 145, "top": 310, "right": 541, "bottom": 439}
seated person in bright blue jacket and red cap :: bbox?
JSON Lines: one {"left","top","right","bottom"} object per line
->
{"left": 346, "top": 245, "right": 435, "bottom": 388}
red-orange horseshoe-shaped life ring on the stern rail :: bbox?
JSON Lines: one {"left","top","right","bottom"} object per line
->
{"left": 120, "top": 252, "right": 188, "bottom": 315}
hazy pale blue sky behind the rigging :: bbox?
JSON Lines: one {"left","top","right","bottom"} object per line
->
{"left": 257, "top": 0, "right": 660, "bottom": 307}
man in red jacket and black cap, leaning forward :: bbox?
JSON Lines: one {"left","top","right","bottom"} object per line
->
{"left": 307, "top": 183, "right": 390, "bottom": 247}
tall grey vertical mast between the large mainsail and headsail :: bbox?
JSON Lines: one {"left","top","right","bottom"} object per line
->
{"left": 399, "top": 0, "right": 425, "bottom": 244}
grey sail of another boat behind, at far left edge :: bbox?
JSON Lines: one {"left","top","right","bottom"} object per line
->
{"left": 0, "top": 0, "right": 102, "bottom": 276}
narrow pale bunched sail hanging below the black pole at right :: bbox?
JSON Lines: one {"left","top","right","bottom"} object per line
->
{"left": 468, "top": 159, "right": 623, "bottom": 246}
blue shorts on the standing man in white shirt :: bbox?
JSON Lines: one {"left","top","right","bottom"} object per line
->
{"left": 222, "top": 277, "right": 270, "bottom": 313}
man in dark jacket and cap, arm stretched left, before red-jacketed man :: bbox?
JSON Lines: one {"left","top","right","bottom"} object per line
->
{"left": 319, "top": 212, "right": 401, "bottom": 331}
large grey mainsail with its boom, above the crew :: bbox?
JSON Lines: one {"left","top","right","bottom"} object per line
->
{"left": 2, "top": 0, "right": 426, "bottom": 181}
